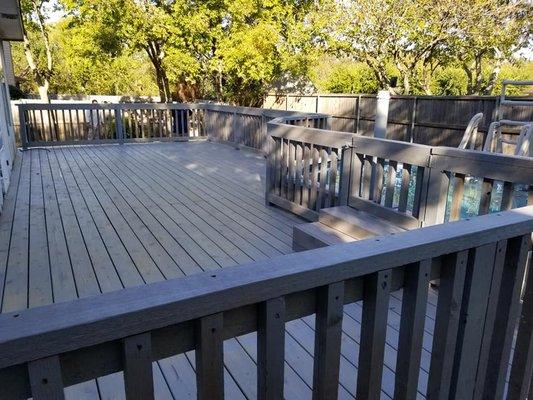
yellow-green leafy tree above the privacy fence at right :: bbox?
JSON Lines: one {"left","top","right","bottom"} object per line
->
{"left": 326, "top": 0, "right": 533, "bottom": 94}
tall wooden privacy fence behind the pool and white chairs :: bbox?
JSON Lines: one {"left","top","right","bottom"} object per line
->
{"left": 264, "top": 94, "right": 533, "bottom": 147}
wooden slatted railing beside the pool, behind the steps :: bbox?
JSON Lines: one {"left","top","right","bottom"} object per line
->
{"left": 266, "top": 117, "right": 533, "bottom": 223}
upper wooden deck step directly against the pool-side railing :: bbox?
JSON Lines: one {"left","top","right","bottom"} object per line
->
{"left": 318, "top": 206, "right": 404, "bottom": 239}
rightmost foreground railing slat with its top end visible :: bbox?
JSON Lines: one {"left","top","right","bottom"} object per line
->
{"left": 484, "top": 235, "right": 531, "bottom": 399}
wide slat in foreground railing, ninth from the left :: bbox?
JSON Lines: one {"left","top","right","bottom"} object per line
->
{"left": 450, "top": 243, "right": 497, "bottom": 399}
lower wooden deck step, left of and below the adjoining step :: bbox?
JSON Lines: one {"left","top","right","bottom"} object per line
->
{"left": 292, "top": 222, "right": 358, "bottom": 251}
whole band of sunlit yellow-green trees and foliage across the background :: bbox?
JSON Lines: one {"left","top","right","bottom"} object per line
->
{"left": 14, "top": 0, "right": 533, "bottom": 101}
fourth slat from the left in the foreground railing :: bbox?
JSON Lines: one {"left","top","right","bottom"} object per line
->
{"left": 257, "top": 297, "right": 285, "bottom": 400}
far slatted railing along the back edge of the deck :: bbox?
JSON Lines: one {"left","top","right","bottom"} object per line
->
{"left": 18, "top": 103, "right": 329, "bottom": 151}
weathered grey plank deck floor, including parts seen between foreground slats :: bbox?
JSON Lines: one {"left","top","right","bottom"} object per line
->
{"left": 0, "top": 142, "right": 436, "bottom": 400}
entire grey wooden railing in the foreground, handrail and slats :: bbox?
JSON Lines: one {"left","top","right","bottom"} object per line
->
{"left": 0, "top": 207, "right": 533, "bottom": 400}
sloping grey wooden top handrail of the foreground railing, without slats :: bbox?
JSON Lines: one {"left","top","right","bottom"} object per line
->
{"left": 0, "top": 206, "right": 533, "bottom": 369}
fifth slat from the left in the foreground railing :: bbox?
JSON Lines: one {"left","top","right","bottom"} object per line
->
{"left": 313, "top": 282, "right": 344, "bottom": 400}
